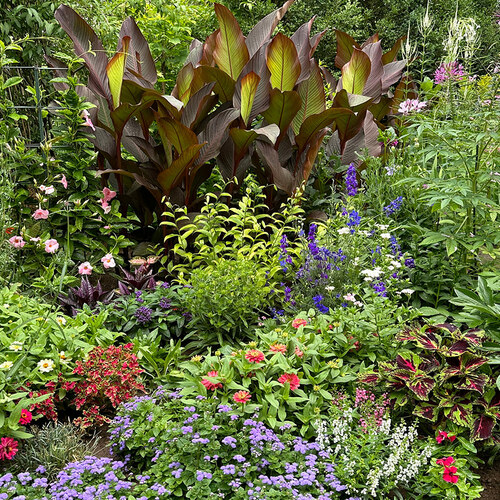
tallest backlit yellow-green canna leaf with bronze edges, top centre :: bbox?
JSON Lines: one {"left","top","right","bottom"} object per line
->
{"left": 213, "top": 3, "right": 250, "bottom": 80}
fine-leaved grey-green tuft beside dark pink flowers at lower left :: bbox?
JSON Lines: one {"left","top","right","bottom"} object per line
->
{"left": 9, "top": 422, "right": 98, "bottom": 480}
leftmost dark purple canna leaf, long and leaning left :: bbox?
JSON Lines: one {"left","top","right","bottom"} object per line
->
{"left": 54, "top": 5, "right": 112, "bottom": 106}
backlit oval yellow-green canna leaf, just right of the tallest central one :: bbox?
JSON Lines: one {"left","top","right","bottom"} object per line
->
{"left": 266, "top": 33, "right": 301, "bottom": 92}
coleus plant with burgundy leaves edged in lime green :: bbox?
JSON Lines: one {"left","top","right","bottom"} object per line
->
{"left": 360, "top": 324, "right": 500, "bottom": 441}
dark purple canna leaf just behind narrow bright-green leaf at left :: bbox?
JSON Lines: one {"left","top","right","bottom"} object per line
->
{"left": 120, "top": 17, "right": 158, "bottom": 85}
